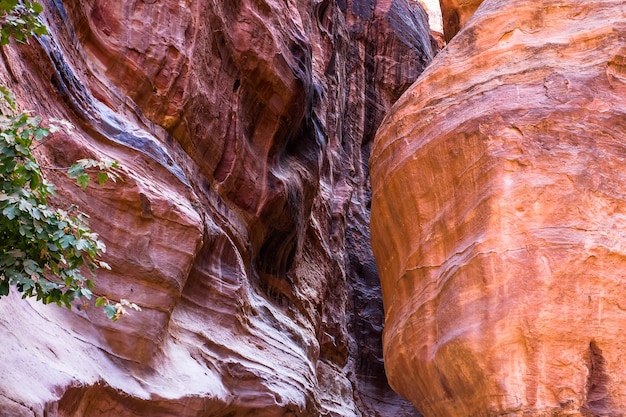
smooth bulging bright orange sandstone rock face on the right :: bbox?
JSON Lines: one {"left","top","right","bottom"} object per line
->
{"left": 371, "top": 0, "right": 626, "bottom": 417}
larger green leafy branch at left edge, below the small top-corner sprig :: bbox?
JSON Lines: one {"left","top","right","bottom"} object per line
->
{"left": 0, "top": 87, "right": 113, "bottom": 308}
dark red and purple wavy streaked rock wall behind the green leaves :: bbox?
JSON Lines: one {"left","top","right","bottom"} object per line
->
{"left": 0, "top": 0, "right": 435, "bottom": 417}
